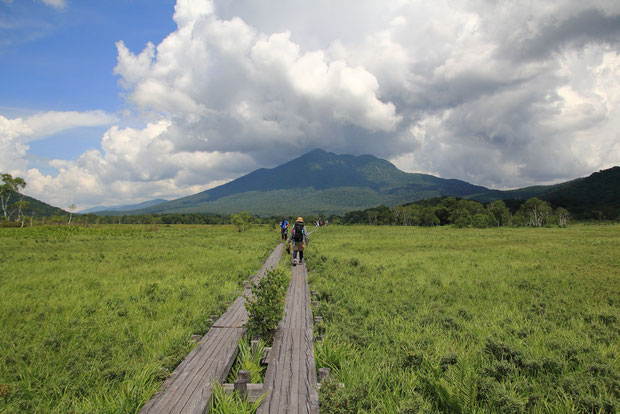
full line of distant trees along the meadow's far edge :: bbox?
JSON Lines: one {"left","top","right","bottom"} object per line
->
{"left": 0, "top": 174, "right": 616, "bottom": 231}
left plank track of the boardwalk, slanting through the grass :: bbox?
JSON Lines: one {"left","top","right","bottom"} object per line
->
{"left": 140, "top": 244, "right": 283, "bottom": 414}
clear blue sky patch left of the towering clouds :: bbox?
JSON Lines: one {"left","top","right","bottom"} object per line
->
{"left": 0, "top": 0, "right": 175, "bottom": 163}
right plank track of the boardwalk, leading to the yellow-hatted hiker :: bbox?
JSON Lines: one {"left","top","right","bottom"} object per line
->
{"left": 258, "top": 265, "right": 319, "bottom": 414}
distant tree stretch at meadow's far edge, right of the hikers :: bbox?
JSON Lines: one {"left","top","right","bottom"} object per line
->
{"left": 340, "top": 197, "right": 570, "bottom": 228}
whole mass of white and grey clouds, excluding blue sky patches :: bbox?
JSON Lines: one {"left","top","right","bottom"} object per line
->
{"left": 10, "top": 0, "right": 620, "bottom": 204}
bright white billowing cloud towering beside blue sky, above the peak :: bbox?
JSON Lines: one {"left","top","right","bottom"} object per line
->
{"left": 115, "top": 2, "right": 400, "bottom": 139}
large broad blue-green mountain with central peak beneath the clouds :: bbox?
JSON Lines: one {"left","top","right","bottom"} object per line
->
{"left": 98, "top": 149, "right": 489, "bottom": 216}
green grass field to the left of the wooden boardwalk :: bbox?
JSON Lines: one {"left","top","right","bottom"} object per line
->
{"left": 0, "top": 225, "right": 279, "bottom": 413}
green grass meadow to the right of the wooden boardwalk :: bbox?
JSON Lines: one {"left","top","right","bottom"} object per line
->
{"left": 306, "top": 226, "right": 620, "bottom": 413}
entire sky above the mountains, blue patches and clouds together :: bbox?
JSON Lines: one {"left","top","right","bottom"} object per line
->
{"left": 0, "top": 0, "right": 620, "bottom": 208}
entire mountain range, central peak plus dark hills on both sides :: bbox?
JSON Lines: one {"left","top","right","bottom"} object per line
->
{"left": 6, "top": 149, "right": 620, "bottom": 219}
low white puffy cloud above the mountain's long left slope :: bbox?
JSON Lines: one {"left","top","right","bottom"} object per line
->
{"left": 21, "top": 120, "right": 256, "bottom": 206}
